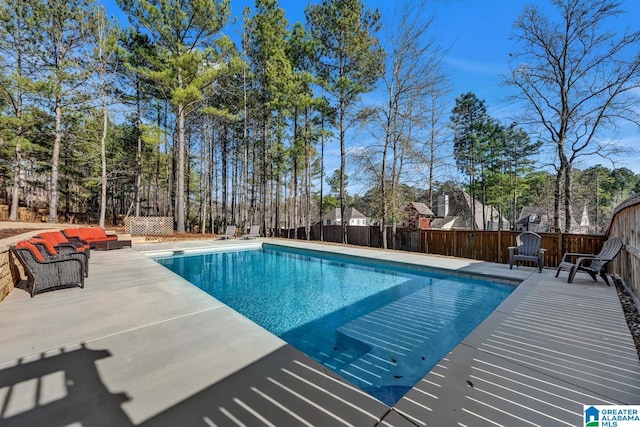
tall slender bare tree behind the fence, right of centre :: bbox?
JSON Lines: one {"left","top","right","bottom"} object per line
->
{"left": 360, "top": 1, "right": 446, "bottom": 248}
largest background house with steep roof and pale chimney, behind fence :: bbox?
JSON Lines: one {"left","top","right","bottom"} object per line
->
{"left": 431, "top": 191, "right": 511, "bottom": 230}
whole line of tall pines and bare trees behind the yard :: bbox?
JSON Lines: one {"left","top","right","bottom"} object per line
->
{"left": 0, "top": 0, "right": 640, "bottom": 242}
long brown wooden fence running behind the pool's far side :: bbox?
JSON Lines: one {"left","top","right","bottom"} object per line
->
{"left": 283, "top": 226, "right": 604, "bottom": 268}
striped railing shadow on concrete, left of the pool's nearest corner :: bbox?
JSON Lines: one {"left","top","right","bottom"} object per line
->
{"left": 140, "top": 345, "right": 390, "bottom": 426}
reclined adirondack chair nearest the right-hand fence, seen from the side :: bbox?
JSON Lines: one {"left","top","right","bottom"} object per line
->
{"left": 556, "top": 237, "right": 624, "bottom": 286}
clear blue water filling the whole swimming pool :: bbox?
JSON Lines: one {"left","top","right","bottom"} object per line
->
{"left": 157, "top": 245, "right": 514, "bottom": 405}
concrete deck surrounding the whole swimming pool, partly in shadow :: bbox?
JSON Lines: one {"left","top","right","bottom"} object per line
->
{"left": 0, "top": 239, "right": 640, "bottom": 426}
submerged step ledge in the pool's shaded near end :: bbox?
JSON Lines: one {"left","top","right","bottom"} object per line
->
{"left": 325, "top": 279, "right": 492, "bottom": 395}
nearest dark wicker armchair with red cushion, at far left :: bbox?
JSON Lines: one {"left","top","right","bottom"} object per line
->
{"left": 11, "top": 241, "right": 84, "bottom": 298}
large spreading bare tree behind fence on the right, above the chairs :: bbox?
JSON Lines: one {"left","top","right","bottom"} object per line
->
{"left": 506, "top": 0, "right": 640, "bottom": 232}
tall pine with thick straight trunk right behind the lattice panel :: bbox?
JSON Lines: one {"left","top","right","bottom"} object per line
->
{"left": 118, "top": 0, "right": 230, "bottom": 233}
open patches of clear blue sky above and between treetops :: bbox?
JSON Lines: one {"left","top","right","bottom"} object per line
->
{"left": 103, "top": 0, "right": 640, "bottom": 182}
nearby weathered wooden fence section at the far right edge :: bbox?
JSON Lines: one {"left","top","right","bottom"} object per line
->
{"left": 608, "top": 195, "right": 640, "bottom": 296}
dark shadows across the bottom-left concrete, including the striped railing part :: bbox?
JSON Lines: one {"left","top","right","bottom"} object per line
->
{"left": 0, "top": 345, "right": 415, "bottom": 427}
